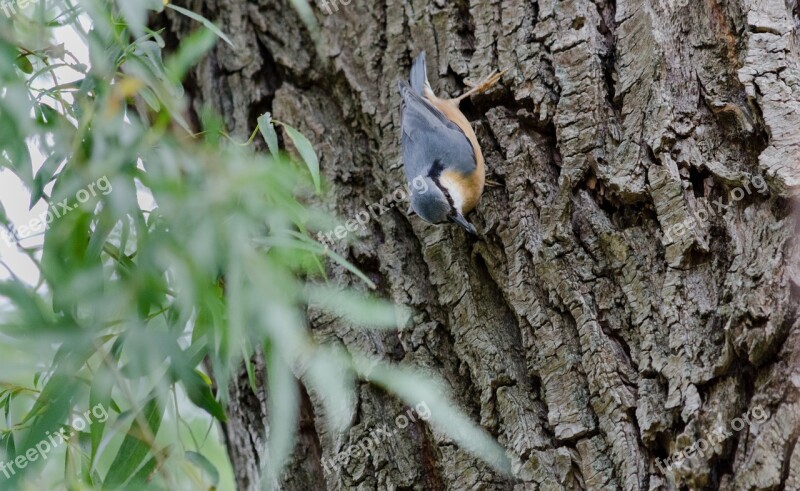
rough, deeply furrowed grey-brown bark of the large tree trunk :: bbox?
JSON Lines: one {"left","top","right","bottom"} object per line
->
{"left": 153, "top": 0, "right": 800, "bottom": 490}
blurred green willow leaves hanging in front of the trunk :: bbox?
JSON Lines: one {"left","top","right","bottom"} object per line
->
{"left": 0, "top": 0, "right": 505, "bottom": 489}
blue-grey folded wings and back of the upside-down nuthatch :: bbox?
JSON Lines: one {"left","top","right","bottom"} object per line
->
{"left": 398, "top": 81, "right": 477, "bottom": 179}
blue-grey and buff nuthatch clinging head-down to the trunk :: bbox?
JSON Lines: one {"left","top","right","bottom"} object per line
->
{"left": 398, "top": 51, "right": 505, "bottom": 234}
